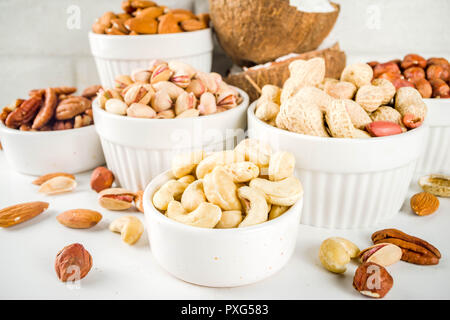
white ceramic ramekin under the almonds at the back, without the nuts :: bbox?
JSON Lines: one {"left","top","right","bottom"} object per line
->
{"left": 89, "top": 29, "right": 213, "bottom": 88}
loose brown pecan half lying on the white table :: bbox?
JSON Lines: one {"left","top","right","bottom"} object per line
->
{"left": 372, "top": 229, "right": 441, "bottom": 265}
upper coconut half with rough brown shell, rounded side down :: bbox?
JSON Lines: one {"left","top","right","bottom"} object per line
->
{"left": 209, "top": 0, "right": 340, "bottom": 66}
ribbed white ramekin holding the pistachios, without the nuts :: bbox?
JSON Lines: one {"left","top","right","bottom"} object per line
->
{"left": 93, "top": 88, "right": 249, "bottom": 190}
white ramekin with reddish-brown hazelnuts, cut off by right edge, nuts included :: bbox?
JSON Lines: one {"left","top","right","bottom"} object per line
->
{"left": 369, "top": 54, "right": 450, "bottom": 174}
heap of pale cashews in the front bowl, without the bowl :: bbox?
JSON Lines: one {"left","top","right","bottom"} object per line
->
{"left": 152, "top": 139, "right": 303, "bottom": 229}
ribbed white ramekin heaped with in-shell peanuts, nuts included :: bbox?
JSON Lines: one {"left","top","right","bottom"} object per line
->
{"left": 248, "top": 58, "right": 428, "bottom": 229}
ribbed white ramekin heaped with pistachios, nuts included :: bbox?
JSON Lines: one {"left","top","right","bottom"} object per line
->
{"left": 93, "top": 60, "right": 249, "bottom": 190}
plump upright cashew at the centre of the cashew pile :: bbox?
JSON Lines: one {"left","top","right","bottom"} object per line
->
{"left": 203, "top": 167, "right": 241, "bottom": 211}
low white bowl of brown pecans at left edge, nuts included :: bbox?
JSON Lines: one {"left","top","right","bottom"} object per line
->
{"left": 0, "top": 86, "right": 105, "bottom": 175}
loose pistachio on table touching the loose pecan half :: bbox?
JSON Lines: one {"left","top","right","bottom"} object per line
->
{"left": 358, "top": 243, "right": 402, "bottom": 267}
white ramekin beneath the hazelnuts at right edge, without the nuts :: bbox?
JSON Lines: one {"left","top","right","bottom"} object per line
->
{"left": 416, "top": 99, "right": 450, "bottom": 175}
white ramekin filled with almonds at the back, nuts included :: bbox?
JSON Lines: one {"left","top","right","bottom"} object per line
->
{"left": 89, "top": 1, "right": 213, "bottom": 87}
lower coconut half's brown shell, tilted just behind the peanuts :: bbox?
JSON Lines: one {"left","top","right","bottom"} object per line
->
{"left": 225, "top": 43, "right": 346, "bottom": 101}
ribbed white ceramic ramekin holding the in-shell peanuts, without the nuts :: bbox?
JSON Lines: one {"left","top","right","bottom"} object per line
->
{"left": 248, "top": 103, "right": 428, "bottom": 229}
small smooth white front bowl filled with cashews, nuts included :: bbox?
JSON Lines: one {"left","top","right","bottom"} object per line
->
{"left": 144, "top": 140, "right": 303, "bottom": 287}
